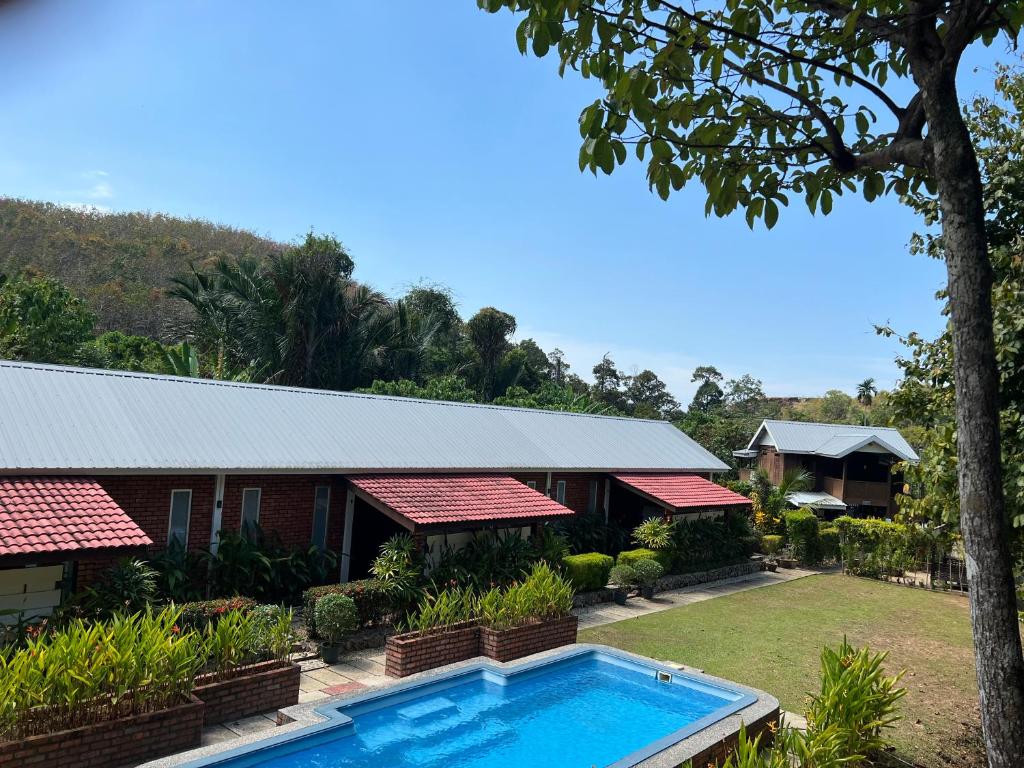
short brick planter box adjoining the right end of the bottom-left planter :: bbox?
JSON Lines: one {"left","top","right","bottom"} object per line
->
{"left": 194, "top": 662, "right": 301, "bottom": 725}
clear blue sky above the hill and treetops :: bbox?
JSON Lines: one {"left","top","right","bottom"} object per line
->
{"left": 0, "top": 0, "right": 1001, "bottom": 401}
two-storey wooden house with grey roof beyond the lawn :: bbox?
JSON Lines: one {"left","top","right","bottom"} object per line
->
{"left": 732, "top": 419, "right": 919, "bottom": 516}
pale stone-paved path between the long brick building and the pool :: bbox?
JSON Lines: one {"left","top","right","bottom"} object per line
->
{"left": 197, "top": 568, "right": 820, "bottom": 746}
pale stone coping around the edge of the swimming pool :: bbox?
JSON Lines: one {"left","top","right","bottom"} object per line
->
{"left": 138, "top": 643, "right": 779, "bottom": 768}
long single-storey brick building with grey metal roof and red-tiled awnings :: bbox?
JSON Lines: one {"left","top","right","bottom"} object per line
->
{"left": 0, "top": 361, "right": 749, "bottom": 611}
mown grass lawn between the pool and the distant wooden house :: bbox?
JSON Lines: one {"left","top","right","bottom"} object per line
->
{"left": 580, "top": 574, "right": 984, "bottom": 768}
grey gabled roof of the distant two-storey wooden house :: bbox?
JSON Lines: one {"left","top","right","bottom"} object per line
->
{"left": 735, "top": 419, "right": 919, "bottom": 462}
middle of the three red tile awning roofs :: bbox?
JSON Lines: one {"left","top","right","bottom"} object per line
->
{"left": 348, "top": 474, "right": 573, "bottom": 526}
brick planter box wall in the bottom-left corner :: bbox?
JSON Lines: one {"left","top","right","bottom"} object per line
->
{"left": 0, "top": 696, "right": 205, "bottom": 768}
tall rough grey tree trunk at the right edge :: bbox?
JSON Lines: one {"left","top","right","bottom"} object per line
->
{"left": 912, "top": 56, "right": 1024, "bottom": 768}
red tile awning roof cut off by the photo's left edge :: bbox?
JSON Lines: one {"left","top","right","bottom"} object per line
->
{"left": 0, "top": 477, "right": 153, "bottom": 556}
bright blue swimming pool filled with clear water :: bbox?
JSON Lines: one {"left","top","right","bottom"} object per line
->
{"left": 188, "top": 647, "right": 757, "bottom": 768}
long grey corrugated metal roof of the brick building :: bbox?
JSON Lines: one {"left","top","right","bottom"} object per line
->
{"left": 0, "top": 360, "right": 728, "bottom": 472}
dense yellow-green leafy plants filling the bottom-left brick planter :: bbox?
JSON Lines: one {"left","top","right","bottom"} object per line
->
{"left": 0, "top": 607, "right": 205, "bottom": 742}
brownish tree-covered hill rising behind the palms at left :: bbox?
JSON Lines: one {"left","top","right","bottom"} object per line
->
{"left": 0, "top": 198, "right": 286, "bottom": 338}
